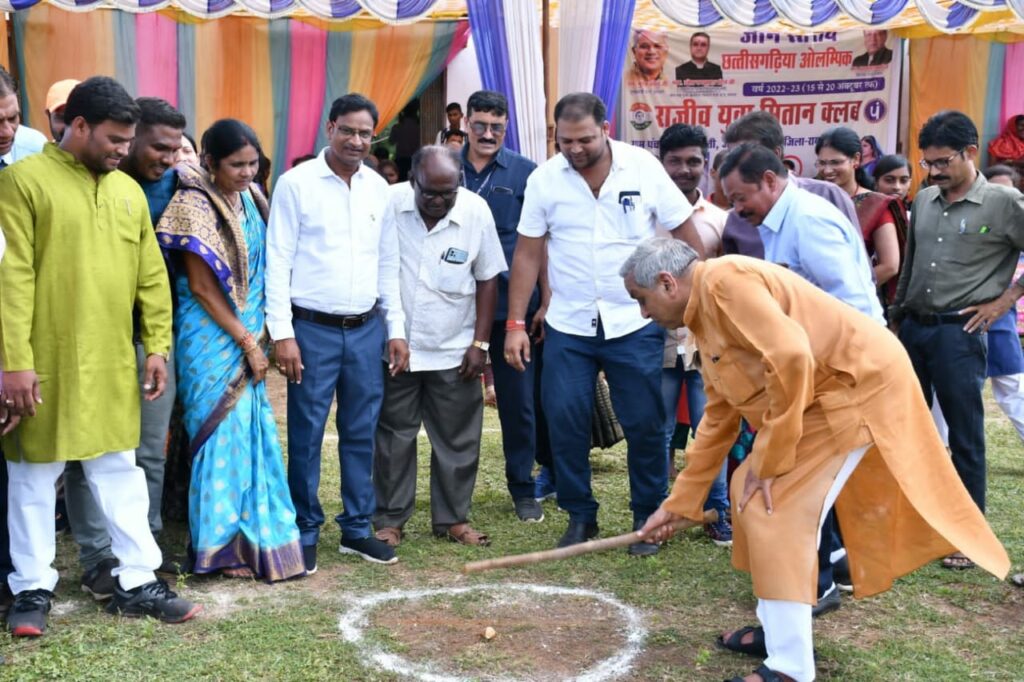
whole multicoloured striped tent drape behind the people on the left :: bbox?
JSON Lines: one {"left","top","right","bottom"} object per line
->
{"left": 14, "top": 3, "right": 468, "bottom": 180}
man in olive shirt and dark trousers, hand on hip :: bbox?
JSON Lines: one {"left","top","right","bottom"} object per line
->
{"left": 890, "top": 112, "right": 1024, "bottom": 548}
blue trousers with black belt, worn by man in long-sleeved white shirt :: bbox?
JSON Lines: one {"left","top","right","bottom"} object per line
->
{"left": 288, "top": 314, "right": 387, "bottom": 546}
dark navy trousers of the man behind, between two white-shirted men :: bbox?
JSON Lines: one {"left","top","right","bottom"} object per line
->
{"left": 490, "top": 319, "right": 551, "bottom": 500}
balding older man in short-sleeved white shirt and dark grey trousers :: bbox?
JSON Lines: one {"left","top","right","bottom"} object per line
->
{"left": 374, "top": 145, "right": 507, "bottom": 546}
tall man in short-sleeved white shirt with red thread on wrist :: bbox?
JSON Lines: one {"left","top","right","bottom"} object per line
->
{"left": 505, "top": 93, "right": 703, "bottom": 556}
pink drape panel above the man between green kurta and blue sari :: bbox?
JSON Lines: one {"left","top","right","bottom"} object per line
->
{"left": 135, "top": 12, "right": 178, "bottom": 106}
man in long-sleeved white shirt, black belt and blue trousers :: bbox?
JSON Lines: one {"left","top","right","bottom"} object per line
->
{"left": 266, "top": 93, "right": 409, "bottom": 572}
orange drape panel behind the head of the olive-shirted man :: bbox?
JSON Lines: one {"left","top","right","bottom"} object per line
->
{"left": 907, "top": 36, "right": 990, "bottom": 187}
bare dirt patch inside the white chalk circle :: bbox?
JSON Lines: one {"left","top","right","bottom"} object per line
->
{"left": 369, "top": 591, "right": 629, "bottom": 680}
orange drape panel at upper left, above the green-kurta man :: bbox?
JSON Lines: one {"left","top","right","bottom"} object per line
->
{"left": 18, "top": 3, "right": 115, "bottom": 132}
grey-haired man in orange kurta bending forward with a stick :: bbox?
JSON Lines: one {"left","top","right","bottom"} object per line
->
{"left": 622, "top": 240, "right": 1010, "bottom": 682}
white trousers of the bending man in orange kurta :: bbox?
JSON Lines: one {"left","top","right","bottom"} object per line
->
{"left": 758, "top": 445, "right": 870, "bottom": 682}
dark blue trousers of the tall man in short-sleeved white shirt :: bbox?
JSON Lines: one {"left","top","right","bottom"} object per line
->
{"left": 541, "top": 324, "right": 669, "bottom": 523}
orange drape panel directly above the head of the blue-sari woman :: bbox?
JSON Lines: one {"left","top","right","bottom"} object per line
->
{"left": 196, "top": 16, "right": 282, "bottom": 163}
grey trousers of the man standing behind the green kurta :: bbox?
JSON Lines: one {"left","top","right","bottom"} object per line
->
{"left": 65, "top": 344, "right": 176, "bottom": 570}
